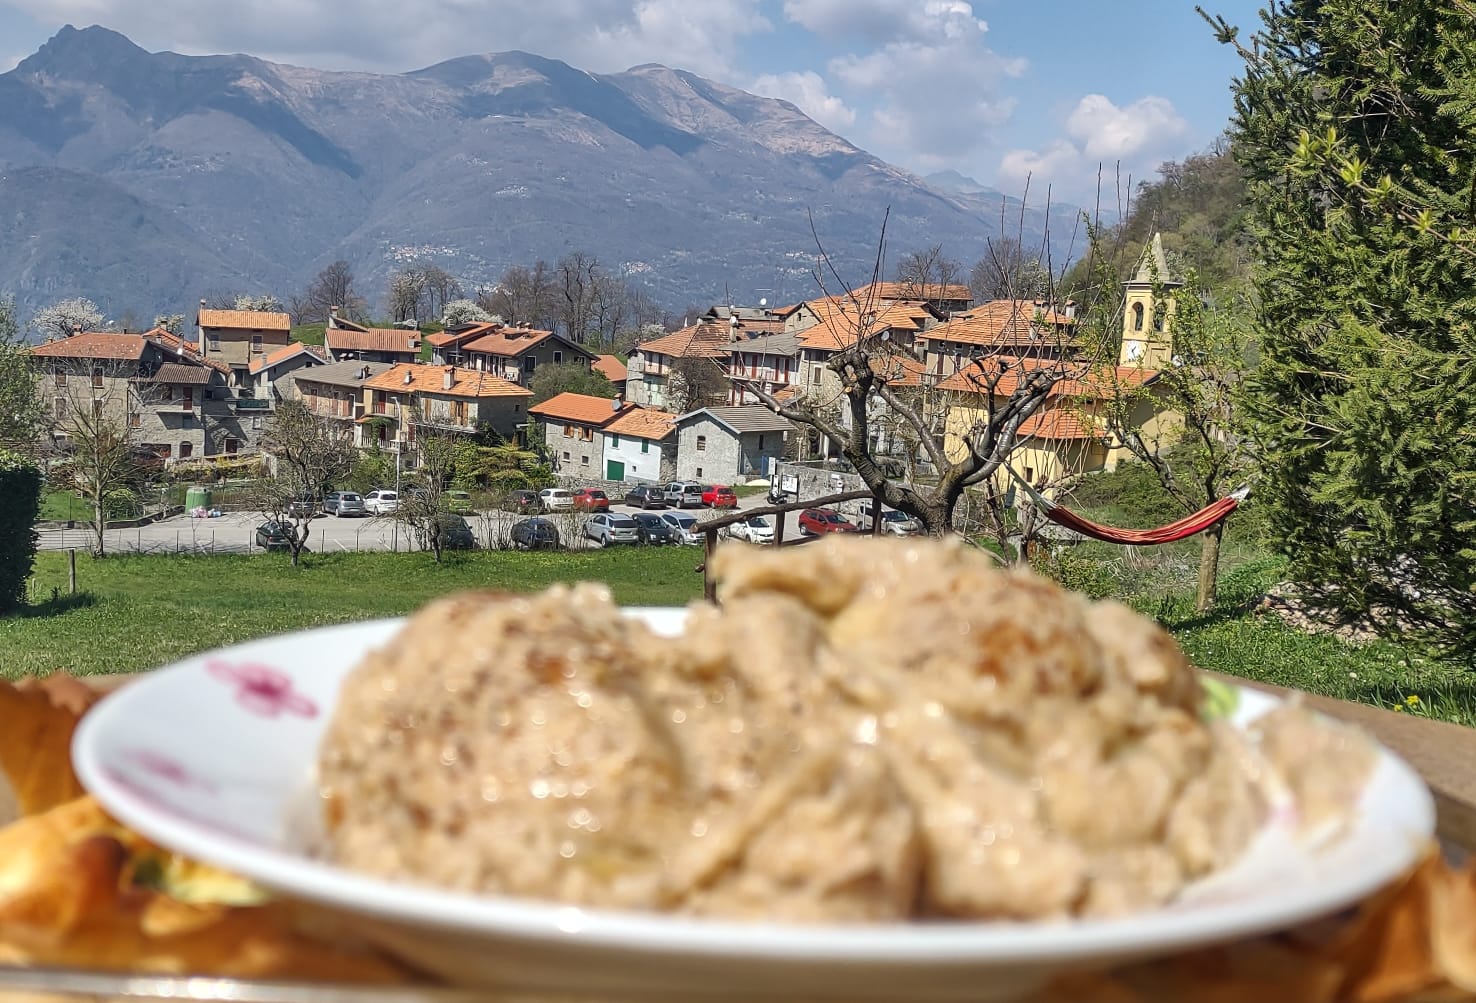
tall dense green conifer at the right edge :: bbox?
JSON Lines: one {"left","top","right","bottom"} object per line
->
{"left": 1216, "top": 0, "right": 1476, "bottom": 661}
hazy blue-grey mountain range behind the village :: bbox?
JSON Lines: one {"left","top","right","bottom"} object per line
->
{"left": 0, "top": 25, "right": 1076, "bottom": 317}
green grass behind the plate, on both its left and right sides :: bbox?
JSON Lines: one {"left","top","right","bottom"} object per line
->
{"left": 0, "top": 547, "right": 1476, "bottom": 726}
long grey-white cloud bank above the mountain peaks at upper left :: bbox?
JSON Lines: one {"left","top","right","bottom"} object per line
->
{"left": 9, "top": 0, "right": 772, "bottom": 80}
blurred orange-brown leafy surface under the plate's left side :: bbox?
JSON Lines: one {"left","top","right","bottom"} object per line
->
{"left": 0, "top": 676, "right": 407, "bottom": 982}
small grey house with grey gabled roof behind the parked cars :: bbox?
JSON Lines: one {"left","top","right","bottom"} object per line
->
{"left": 676, "top": 404, "right": 794, "bottom": 482}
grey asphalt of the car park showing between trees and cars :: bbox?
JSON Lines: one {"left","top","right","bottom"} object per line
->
{"left": 37, "top": 494, "right": 820, "bottom": 553}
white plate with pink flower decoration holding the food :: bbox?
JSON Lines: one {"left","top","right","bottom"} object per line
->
{"left": 74, "top": 609, "right": 1435, "bottom": 1002}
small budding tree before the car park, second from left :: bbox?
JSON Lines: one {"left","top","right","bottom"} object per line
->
{"left": 255, "top": 397, "right": 354, "bottom": 568}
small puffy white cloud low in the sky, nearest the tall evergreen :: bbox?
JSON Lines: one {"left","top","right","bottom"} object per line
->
{"left": 998, "top": 94, "right": 1190, "bottom": 199}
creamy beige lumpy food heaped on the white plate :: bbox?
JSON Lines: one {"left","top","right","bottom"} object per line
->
{"left": 319, "top": 538, "right": 1374, "bottom": 922}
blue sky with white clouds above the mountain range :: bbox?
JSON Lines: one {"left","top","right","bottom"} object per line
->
{"left": 0, "top": 0, "right": 1259, "bottom": 202}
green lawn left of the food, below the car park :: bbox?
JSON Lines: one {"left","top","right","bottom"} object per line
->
{"left": 0, "top": 547, "right": 703, "bottom": 679}
